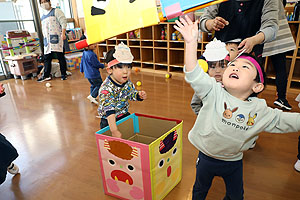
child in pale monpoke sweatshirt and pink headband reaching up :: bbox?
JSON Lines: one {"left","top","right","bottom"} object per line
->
{"left": 174, "top": 17, "right": 300, "bottom": 200}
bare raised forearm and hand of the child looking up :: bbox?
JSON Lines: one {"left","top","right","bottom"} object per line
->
{"left": 174, "top": 16, "right": 198, "bottom": 72}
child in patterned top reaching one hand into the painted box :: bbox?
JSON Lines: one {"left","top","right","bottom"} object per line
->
{"left": 98, "top": 43, "right": 147, "bottom": 138}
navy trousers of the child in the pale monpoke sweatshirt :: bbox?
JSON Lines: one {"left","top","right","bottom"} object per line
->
{"left": 193, "top": 152, "right": 244, "bottom": 200}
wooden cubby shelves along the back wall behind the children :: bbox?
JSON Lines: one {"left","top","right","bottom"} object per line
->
{"left": 97, "top": 21, "right": 300, "bottom": 90}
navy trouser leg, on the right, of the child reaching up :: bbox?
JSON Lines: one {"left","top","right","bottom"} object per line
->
{"left": 222, "top": 160, "right": 244, "bottom": 200}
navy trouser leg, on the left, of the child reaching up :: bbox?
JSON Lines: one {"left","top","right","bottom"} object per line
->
{"left": 192, "top": 152, "right": 214, "bottom": 200}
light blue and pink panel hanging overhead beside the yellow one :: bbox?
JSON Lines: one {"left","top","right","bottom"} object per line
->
{"left": 160, "top": 0, "right": 227, "bottom": 20}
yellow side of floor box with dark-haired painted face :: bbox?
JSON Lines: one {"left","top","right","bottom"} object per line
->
{"left": 150, "top": 127, "right": 182, "bottom": 199}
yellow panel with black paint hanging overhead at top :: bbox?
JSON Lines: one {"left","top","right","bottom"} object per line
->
{"left": 82, "top": 0, "right": 159, "bottom": 44}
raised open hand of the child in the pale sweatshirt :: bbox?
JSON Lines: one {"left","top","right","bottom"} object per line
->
{"left": 174, "top": 16, "right": 198, "bottom": 43}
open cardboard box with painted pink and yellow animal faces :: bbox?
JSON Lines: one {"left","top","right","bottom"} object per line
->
{"left": 96, "top": 113, "right": 183, "bottom": 200}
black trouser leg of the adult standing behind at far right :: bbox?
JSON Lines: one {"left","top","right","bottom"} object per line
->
{"left": 270, "top": 53, "right": 287, "bottom": 99}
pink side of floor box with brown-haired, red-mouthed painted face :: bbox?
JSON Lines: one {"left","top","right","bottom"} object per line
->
{"left": 100, "top": 140, "right": 144, "bottom": 199}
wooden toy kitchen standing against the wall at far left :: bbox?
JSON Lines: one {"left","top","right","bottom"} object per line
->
{"left": 1, "top": 30, "right": 38, "bottom": 80}
